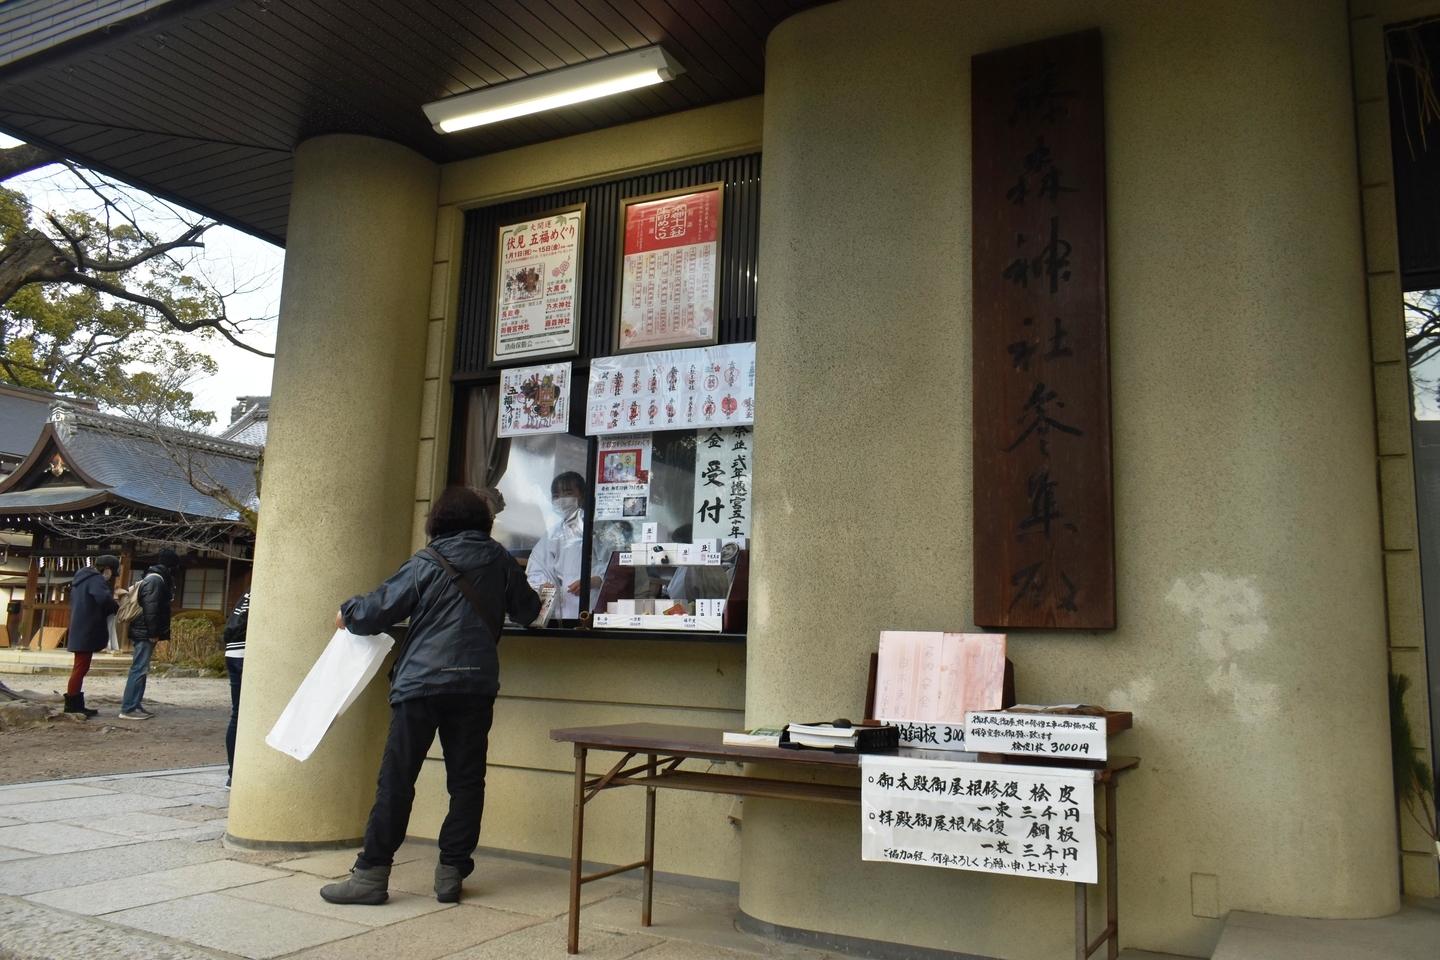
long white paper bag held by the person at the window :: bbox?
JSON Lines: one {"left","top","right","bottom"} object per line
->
{"left": 265, "top": 630, "right": 395, "bottom": 761}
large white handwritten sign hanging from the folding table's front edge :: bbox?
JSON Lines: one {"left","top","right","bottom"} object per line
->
{"left": 860, "top": 754, "right": 1096, "bottom": 884}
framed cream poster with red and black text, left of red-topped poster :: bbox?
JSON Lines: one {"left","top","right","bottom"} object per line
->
{"left": 490, "top": 203, "right": 585, "bottom": 363}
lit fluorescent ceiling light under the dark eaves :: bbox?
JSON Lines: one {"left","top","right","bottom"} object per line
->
{"left": 425, "top": 46, "right": 685, "bottom": 134}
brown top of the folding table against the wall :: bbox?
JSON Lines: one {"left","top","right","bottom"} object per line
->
{"left": 550, "top": 724, "right": 1140, "bottom": 773}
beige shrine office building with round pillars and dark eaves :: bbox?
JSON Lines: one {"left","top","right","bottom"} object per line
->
{"left": 0, "top": 0, "right": 1440, "bottom": 960}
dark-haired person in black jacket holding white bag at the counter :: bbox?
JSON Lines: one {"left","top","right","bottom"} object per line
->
{"left": 320, "top": 486, "right": 540, "bottom": 904}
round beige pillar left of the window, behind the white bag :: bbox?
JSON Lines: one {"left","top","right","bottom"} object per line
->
{"left": 228, "top": 135, "right": 439, "bottom": 849}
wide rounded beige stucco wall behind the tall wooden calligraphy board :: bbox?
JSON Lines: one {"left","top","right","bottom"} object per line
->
{"left": 740, "top": 0, "right": 1398, "bottom": 960}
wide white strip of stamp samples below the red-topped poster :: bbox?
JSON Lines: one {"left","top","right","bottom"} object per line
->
{"left": 585, "top": 343, "right": 755, "bottom": 436}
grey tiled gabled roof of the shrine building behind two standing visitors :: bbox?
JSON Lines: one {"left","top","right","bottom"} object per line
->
{"left": 0, "top": 402, "right": 261, "bottom": 522}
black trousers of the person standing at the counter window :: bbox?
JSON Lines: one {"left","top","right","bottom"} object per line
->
{"left": 356, "top": 694, "right": 495, "bottom": 877}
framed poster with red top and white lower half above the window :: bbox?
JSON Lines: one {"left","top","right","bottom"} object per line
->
{"left": 615, "top": 183, "right": 724, "bottom": 353}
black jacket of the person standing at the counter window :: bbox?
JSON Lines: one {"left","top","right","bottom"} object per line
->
{"left": 340, "top": 531, "right": 540, "bottom": 704}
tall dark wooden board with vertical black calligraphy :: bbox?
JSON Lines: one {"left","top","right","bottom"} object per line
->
{"left": 971, "top": 30, "right": 1115, "bottom": 629}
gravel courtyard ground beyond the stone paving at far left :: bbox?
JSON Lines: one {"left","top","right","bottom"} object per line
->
{"left": 0, "top": 674, "right": 230, "bottom": 783}
